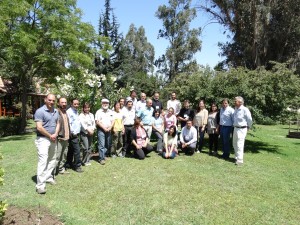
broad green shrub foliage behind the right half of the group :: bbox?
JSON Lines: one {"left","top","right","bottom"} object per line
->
{"left": 165, "top": 63, "right": 300, "bottom": 124}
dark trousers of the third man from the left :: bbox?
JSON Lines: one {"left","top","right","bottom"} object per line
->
{"left": 66, "top": 137, "right": 81, "bottom": 169}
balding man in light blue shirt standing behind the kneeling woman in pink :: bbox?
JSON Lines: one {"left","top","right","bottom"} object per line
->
{"left": 137, "top": 98, "right": 154, "bottom": 139}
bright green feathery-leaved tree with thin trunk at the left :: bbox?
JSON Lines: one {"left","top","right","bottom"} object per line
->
{"left": 0, "top": 0, "right": 101, "bottom": 131}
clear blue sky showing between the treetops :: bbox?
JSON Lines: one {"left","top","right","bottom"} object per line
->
{"left": 77, "top": 0, "right": 228, "bottom": 68}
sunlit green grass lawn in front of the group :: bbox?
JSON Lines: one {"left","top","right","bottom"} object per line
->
{"left": 0, "top": 126, "right": 300, "bottom": 224}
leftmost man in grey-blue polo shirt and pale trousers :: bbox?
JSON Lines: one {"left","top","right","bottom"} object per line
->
{"left": 34, "top": 94, "right": 60, "bottom": 194}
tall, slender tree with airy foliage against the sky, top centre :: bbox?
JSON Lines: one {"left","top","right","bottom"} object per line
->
{"left": 155, "top": 0, "right": 201, "bottom": 80}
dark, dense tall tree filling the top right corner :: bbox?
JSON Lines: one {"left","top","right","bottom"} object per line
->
{"left": 199, "top": 0, "right": 300, "bottom": 69}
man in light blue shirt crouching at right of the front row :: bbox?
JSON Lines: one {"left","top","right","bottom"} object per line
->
{"left": 180, "top": 119, "right": 197, "bottom": 155}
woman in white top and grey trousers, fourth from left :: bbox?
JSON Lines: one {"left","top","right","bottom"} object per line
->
{"left": 79, "top": 102, "right": 96, "bottom": 166}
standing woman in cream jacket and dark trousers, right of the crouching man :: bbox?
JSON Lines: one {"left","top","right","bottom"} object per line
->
{"left": 193, "top": 100, "right": 208, "bottom": 153}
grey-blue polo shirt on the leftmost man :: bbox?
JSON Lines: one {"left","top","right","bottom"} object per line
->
{"left": 34, "top": 105, "right": 59, "bottom": 137}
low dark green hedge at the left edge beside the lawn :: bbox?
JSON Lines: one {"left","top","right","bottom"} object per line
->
{"left": 0, "top": 117, "right": 21, "bottom": 137}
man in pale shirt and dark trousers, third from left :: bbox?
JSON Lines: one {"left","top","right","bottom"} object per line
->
{"left": 66, "top": 98, "right": 83, "bottom": 173}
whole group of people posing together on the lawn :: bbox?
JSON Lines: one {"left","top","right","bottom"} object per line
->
{"left": 34, "top": 90, "right": 252, "bottom": 194}
